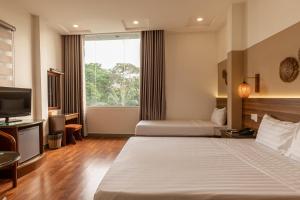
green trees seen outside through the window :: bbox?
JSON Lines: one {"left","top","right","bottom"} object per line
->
{"left": 85, "top": 63, "right": 140, "bottom": 106}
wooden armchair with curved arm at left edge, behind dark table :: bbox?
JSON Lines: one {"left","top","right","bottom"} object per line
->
{"left": 0, "top": 131, "right": 18, "bottom": 187}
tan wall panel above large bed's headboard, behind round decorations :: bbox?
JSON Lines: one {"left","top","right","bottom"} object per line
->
{"left": 245, "top": 23, "right": 300, "bottom": 97}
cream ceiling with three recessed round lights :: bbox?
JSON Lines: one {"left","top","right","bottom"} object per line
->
{"left": 16, "top": 0, "right": 241, "bottom": 34}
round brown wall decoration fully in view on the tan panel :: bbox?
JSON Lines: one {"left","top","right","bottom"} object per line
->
{"left": 279, "top": 57, "right": 299, "bottom": 82}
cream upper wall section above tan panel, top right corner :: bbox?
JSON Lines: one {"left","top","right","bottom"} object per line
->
{"left": 246, "top": 0, "right": 300, "bottom": 47}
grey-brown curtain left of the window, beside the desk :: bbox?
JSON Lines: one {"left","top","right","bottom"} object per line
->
{"left": 63, "top": 35, "right": 83, "bottom": 130}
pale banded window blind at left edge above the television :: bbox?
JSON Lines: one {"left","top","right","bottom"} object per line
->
{"left": 0, "top": 20, "right": 16, "bottom": 87}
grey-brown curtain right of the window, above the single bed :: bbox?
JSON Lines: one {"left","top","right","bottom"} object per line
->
{"left": 140, "top": 30, "right": 166, "bottom": 120}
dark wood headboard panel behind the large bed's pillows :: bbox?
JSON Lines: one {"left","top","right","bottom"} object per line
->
{"left": 243, "top": 98, "right": 300, "bottom": 130}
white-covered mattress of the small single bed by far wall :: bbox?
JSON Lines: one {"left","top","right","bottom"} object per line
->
{"left": 135, "top": 120, "right": 224, "bottom": 136}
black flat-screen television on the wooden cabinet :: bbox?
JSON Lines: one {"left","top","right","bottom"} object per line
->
{"left": 0, "top": 87, "right": 31, "bottom": 123}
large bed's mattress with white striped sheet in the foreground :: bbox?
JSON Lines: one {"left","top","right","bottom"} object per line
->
{"left": 94, "top": 137, "right": 300, "bottom": 200}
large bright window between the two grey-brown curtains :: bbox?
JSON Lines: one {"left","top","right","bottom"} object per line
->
{"left": 85, "top": 33, "right": 140, "bottom": 106}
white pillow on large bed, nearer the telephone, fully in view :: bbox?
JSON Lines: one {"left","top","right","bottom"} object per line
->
{"left": 256, "top": 115, "right": 299, "bottom": 153}
